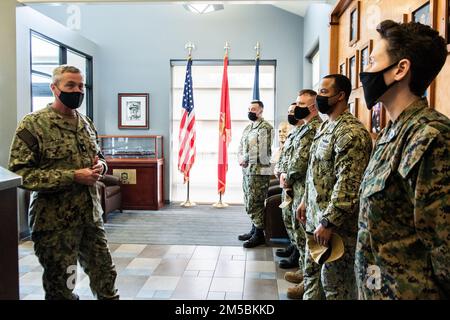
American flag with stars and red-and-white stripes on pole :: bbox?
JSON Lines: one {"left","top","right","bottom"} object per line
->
{"left": 178, "top": 59, "right": 195, "bottom": 183}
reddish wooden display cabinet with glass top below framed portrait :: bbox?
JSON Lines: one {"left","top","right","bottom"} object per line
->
{"left": 99, "top": 135, "right": 164, "bottom": 210}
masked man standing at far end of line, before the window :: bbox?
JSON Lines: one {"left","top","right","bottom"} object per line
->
{"left": 238, "top": 101, "right": 273, "bottom": 248}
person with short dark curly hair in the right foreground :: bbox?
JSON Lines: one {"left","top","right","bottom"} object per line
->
{"left": 355, "top": 20, "right": 450, "bottom": 299}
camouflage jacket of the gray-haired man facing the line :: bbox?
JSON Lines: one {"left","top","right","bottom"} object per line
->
{"left": 9, "top": 105, "right": 105, "bottom": 232}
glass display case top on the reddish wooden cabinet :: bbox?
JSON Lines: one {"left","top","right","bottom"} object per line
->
{"left": 99, "top": 135, "right": 164, "bottom": 159}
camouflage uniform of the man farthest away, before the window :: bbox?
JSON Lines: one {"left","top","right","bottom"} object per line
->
{"left": 238, "top": 119, "right": 273, "bottom": 229}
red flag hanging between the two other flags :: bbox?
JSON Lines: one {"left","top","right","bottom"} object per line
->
{"left": 218, "top": 50, "right": 231, "bottom": 196}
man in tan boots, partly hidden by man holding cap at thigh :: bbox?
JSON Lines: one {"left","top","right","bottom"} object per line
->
{"left": 280, "top": 90, "right": 322, "bottom": 299}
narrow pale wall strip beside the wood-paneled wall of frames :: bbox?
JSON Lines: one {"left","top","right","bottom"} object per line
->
{"left": 303, "top": 3, "right": 333, "bottom": 88}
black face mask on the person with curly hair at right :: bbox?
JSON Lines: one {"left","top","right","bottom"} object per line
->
{"left": 359, "top": 62, "right": 398, "bottom": 110}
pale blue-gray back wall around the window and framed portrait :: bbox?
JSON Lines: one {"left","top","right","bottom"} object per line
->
{"left": 29, "top": 4, "right": 303, "bottom": 197}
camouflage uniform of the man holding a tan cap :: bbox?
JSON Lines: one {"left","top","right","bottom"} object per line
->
{"left": 303, "top": 112, "right": 372, "bottom": 299}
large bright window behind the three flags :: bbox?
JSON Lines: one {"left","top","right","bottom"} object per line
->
{"left": 170, "top": 60, "right": 275, "bottom": 204}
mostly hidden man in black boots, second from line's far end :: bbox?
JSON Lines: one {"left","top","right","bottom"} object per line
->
{"left": 274, "top": 102, "right": 303, "bottom": 269}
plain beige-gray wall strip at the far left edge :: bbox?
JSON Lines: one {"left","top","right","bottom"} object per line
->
{"left": 0, "top": 0, "right": 17, "bottom": 168}
